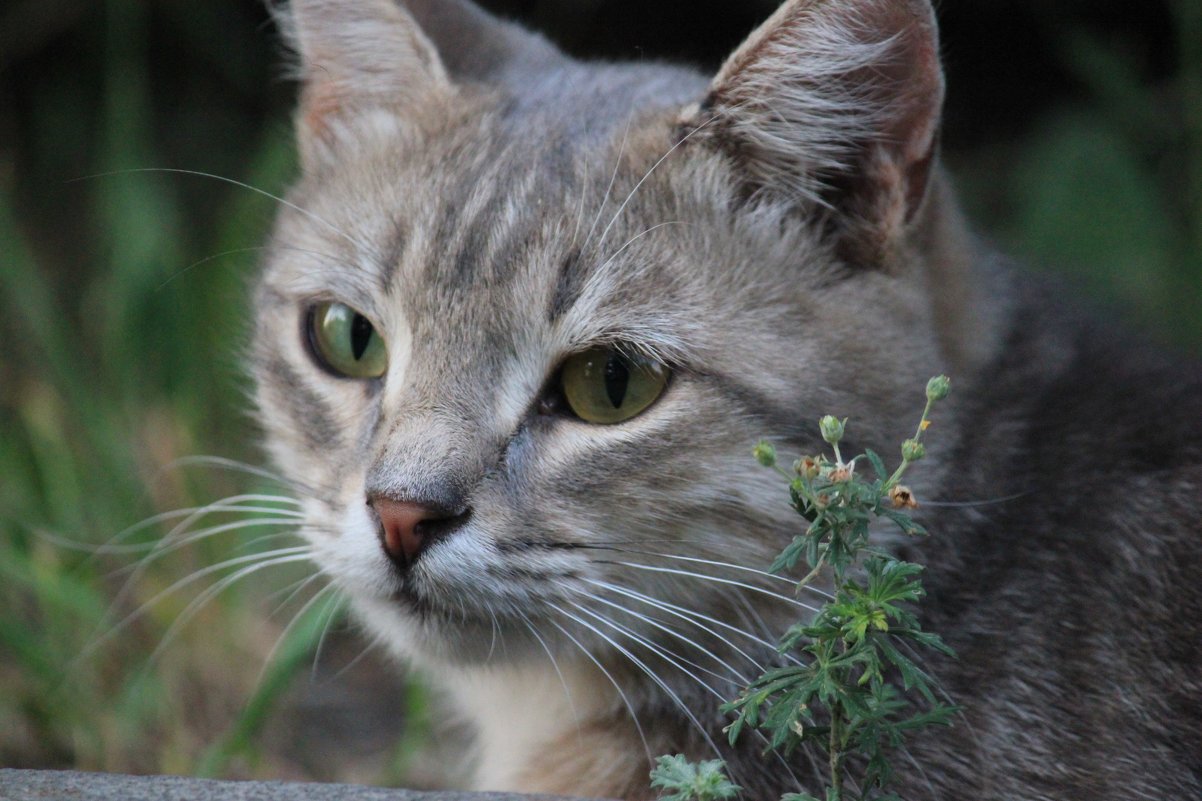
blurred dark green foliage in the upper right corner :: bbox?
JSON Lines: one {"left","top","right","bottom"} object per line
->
{"left": 952, "top": 0, "right": 1202, "bottom": 352}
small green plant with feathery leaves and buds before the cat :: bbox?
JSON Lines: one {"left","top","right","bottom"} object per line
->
{"left": 653, "top": 376, "right": 956, "bottom": 801}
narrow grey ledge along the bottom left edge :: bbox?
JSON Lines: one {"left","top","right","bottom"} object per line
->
{"left": 0, "top": 769, "right": 586, "bottom": 801}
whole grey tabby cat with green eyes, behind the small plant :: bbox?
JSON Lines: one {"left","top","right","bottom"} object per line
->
{"left": 254, "top": 0, "right": 1202, "bottom": 800}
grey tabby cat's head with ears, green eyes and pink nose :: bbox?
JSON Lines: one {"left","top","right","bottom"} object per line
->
{"left": 254, "top": 0, "right": 976, "bottom": 663}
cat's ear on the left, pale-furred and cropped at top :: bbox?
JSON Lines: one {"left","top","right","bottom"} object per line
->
{"left": 281, "top": 0, "right": 453, "bottom": 171}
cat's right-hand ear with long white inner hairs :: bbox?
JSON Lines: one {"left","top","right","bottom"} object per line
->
{"left": 696, "top": 0, "right": 944, "bottom": 265}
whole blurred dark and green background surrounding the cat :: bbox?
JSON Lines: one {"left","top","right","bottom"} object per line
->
{"left": 0, "top": 0, "right": 1202, "bottom": 787}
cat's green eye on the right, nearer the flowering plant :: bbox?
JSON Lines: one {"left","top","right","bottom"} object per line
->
{"left": 560, "top": 348, "right": 668, "bottom": 425}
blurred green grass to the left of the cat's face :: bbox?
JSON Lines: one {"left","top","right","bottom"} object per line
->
{"left": 0, "top": 2, "right": 350, "bottom": 775}
